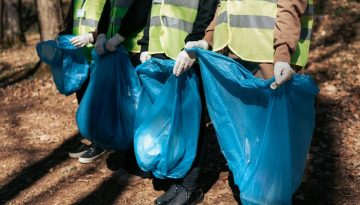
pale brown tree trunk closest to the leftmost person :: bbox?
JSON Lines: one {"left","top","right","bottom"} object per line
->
{"left": 36, "top": 0, "right": 63, "bottom": 41}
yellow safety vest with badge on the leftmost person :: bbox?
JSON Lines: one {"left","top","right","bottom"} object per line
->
{"left": 73, "top": 0, "right": 106, "bottom": 60}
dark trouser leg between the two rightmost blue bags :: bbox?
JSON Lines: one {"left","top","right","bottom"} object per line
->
{"left": 152, "top": 54, "right": 208, "bottom": 190}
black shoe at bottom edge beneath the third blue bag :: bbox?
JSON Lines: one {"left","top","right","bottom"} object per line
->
{"left": 167, "top": 188, "right": 204, "bottom": 205}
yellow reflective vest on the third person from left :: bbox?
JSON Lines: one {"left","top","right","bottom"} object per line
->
{"left": 149, "top": 0, "right": 199, "bottom": 59}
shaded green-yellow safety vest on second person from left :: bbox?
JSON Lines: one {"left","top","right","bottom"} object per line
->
{"left": 107, "top": 0, "right": 143, "bottom": 53}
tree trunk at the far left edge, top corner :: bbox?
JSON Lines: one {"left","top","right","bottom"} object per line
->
{"left": 1, "top": 0, "right": 25, "bottom": 47}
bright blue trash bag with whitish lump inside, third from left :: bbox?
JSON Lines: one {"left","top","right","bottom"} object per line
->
{"left": 134, "top": 59, "right": 201, "bottom": 179}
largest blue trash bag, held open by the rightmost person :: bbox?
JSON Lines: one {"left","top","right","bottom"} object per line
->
{"left": 189, "top": 49, "right": 319, "bottom": 205}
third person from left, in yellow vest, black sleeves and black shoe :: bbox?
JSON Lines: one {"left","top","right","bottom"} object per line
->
{"left": 138, "top": 0, "right": 218, "bottom": 205}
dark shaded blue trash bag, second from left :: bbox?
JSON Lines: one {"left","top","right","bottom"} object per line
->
{"left": 76, "top": 47, "right": 141, "bottom": 150}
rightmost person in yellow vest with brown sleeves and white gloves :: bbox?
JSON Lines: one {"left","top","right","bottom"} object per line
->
{"left": 175, "top": 0, "right": 313, "bottom": 89}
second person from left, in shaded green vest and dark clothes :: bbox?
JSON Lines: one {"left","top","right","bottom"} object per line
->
{"left": 79, "top": 0, "right": 151, "bottom": 185}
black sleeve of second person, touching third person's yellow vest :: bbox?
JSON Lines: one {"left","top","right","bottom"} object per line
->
{"left": 118, "top": 0, "right": 152, "bottom": 38}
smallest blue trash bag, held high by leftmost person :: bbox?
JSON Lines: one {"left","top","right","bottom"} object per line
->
{"left": 36, "top": 35, "right": 89, "bottom": 96}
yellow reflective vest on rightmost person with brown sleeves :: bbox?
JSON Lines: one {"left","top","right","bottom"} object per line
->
{"left": 213, "top": 0, "right": 314, "bottom": 67}
